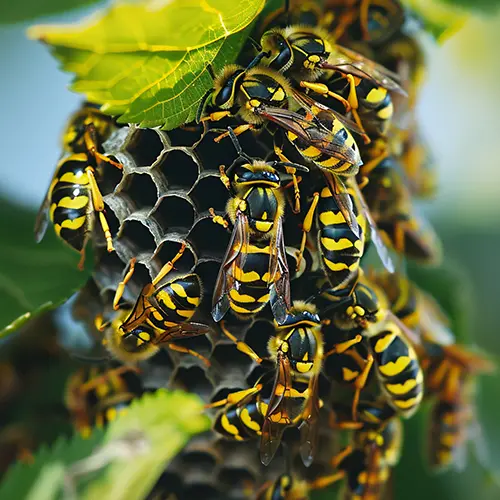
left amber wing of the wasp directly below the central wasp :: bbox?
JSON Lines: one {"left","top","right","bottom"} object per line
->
{"left": 260, "top": 354, "right": 292, "bottom": 465}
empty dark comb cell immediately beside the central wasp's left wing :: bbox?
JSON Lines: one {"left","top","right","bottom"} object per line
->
{"left": 188, "top": 215, "right": 230, "bottom": 259}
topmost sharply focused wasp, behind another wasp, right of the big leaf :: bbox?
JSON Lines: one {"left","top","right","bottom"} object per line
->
{"left": 261, "top": 26, "right": 404, "bottom": 143}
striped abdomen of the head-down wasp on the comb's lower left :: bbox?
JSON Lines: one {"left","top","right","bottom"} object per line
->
{"left": 148, "top": 274, "right": 201, "bottom": 330}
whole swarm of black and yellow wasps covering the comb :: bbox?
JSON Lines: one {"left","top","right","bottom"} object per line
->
{"left": 29, "top": 0, "right": 493, "bottom": 500}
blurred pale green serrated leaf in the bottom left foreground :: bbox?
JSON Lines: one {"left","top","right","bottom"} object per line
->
{"left": 0, "top": 389, "right": 209, "bottom": 500}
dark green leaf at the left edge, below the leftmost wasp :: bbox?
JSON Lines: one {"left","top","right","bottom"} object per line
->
{"left": 0, "top": 199, "right": 91, "bottom": 339}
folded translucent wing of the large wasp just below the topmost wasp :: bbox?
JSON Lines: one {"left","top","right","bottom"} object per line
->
{"left": 256, "top": 105, "right": 362, "bottom": 166}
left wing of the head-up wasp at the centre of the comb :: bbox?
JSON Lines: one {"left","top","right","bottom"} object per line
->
{"left": 212, "top": 212, "right": 249, "bottom": 322}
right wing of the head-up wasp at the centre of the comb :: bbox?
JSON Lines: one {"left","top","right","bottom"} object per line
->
{"left": 269, "top": 217, "right": 292, "bottom": 325}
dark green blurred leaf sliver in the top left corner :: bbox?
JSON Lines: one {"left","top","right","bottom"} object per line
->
{"left": 0, "top": 0, "right": 100, "bottom": 24}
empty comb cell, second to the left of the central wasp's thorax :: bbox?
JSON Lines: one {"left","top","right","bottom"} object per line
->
{"left": 151, "top": 194, "right": 195, "bottom": 233}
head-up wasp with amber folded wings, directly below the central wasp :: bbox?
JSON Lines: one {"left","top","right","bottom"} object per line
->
{"left": 217, "top": 300, "right": 324, "bottom": 465}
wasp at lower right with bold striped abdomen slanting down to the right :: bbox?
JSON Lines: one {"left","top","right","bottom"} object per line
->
{"left": 323, "top": 273, "right": 424, "bottom": 418}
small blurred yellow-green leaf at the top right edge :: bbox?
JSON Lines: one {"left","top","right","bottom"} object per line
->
{"left": 403, "top": 0, "right": 466, "bottom": 42}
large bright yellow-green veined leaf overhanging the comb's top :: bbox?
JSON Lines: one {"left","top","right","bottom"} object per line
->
{"left": 29, "top": 0, "right": 265, "bottom": 129}
